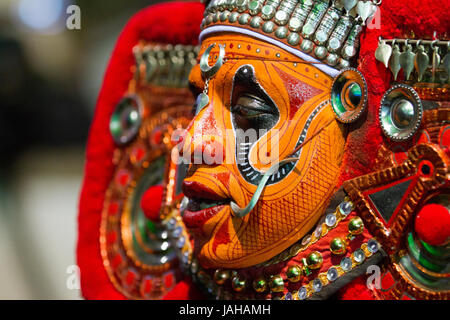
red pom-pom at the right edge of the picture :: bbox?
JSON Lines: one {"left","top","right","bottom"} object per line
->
{"left": 414, "top": 204, "right": 450, "bottom": 246}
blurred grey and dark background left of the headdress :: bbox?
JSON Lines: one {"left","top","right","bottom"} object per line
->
{"left": 0, "top": 0, "right": 159, "bottom": 299}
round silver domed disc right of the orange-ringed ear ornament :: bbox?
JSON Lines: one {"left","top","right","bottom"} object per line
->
{"left": 379, "top": 84, "right": 423, "bottom": 141}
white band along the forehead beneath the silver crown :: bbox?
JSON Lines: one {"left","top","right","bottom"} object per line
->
{"left": 199, "top": 26, "right": 339, "bottom": 77}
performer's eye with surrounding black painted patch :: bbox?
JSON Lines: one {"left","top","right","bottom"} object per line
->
{"left": 231, "top": 66, "right": 279, "bottom": 130}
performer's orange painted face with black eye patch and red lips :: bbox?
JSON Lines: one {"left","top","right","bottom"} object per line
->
{"left": 183, "top": 34, "right": 345, "bottom": 269}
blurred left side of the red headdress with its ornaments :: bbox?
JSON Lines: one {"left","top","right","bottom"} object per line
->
{"left": 78, "top": 2, "right": 203, "bottom": 299}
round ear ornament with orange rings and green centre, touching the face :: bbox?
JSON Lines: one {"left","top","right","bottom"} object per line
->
{"left": 330, "top": 68, "right": 367, "bottom": 123}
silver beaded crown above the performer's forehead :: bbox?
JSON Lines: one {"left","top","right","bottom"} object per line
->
{"left": 201, "top": 0, "right": 381, "bottom": 69}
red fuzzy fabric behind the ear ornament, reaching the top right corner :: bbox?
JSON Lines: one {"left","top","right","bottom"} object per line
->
{"left": 341, "top": 0, "right": 450, "bottom": 182}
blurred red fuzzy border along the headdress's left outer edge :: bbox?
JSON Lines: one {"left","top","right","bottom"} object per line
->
{"left": 77, "top": 2, "right": 204, "bottom": 299}
